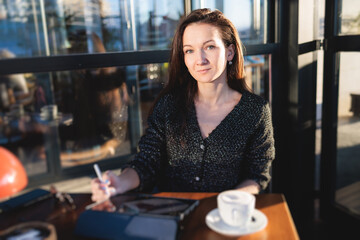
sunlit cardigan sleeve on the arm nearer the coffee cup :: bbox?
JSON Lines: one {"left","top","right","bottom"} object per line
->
{"left": 245, "top": 104, "right": 275, "bottom": 189}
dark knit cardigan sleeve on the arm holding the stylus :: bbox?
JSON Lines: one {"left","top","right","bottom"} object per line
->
{"left": 124, "top": 95, "right": 167, "bottom": 191}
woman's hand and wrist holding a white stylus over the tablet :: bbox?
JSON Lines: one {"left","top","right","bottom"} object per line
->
{"left": 91, "top": 168, "right": 140, "bottom": 202}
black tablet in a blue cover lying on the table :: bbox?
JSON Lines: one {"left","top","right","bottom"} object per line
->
{"left": 75, "top": 193, "right": 199, "bottom": 240}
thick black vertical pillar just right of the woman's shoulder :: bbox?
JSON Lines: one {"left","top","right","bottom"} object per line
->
{"left": 272, "top": 0, "right": 297, "bottom": 197}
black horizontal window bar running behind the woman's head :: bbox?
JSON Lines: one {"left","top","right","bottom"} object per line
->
{"left": 0, "top": 43, "right": 279, "bottom": 75}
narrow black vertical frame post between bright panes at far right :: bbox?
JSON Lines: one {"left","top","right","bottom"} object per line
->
{"left": 320, "top": 1, "right": 339, "bottom": 219}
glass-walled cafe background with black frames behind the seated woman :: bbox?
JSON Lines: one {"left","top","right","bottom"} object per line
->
{"left": 0, "top": 0, "right": 360, "bottom": 239}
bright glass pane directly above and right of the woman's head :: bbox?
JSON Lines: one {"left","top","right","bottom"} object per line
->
{"left": 192, "top": 0, "right": 267, "bottom": 44}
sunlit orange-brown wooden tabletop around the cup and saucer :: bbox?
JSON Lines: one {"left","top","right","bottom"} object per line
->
{"left": 155, "top": 193, "right": 299, "bottom": 240}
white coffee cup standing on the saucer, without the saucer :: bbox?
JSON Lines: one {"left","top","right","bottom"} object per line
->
{"left": 217, "top": 190, "right": 255, "bottom": 227}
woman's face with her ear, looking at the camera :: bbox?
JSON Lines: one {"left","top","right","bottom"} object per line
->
{"left": 183, "top": 23, "right": 234, "bottom": 83}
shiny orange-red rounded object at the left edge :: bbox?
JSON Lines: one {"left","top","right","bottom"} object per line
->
{"left": 0, "top": 147, "right": 28, "bottom": 199}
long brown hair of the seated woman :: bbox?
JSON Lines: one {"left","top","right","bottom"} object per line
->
{"left": 150, "top": 8, "right": 249, "bottom": 125}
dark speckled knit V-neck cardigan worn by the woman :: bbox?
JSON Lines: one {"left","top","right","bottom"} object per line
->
{"left": 126, "top": 92, "right": 275, "bottom": 192}
